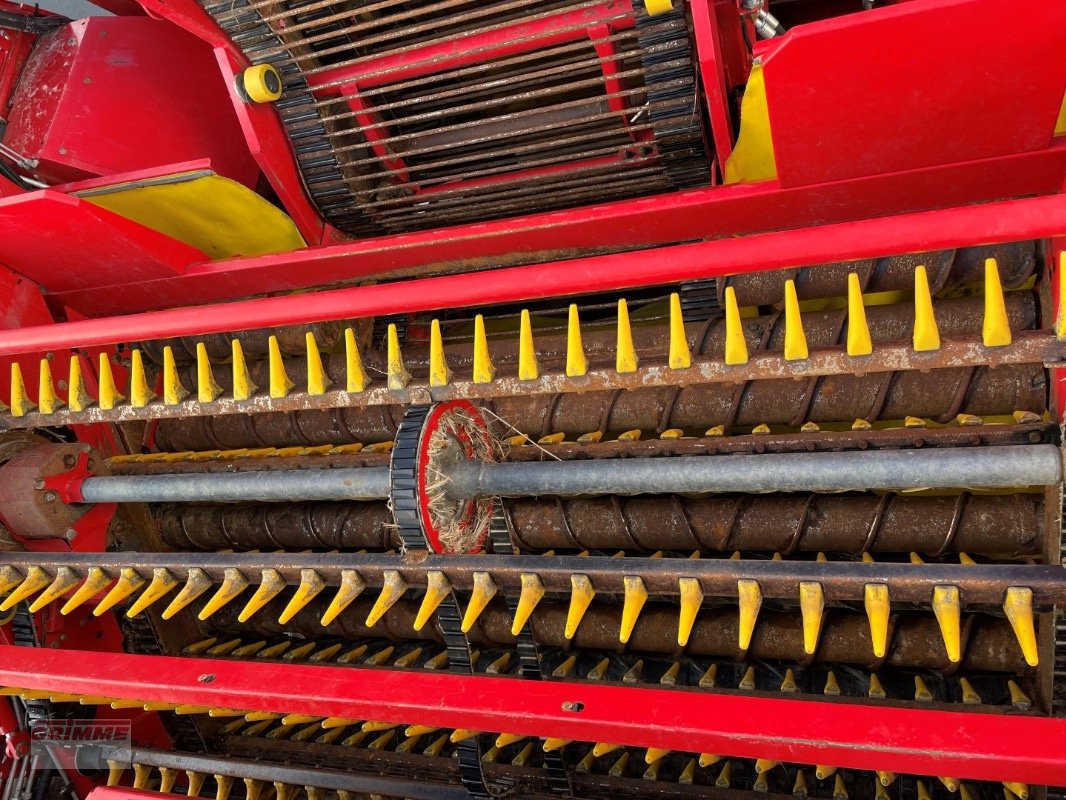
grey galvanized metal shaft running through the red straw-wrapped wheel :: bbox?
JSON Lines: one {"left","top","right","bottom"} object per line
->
{"left": 75, "top": 445, "right": 1063, "bottom": 502}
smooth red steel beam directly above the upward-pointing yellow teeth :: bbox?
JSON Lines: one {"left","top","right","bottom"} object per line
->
{"left": 6, "top": 194, "right": 1066, "bottom": 355}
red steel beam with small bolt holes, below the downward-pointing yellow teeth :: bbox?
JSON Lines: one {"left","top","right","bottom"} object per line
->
{"left": 0, "top": 646, "right": 1066, "bottom": 785}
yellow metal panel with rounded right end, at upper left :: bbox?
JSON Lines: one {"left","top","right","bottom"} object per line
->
{"left": 79, "top": 171, "right": 306, "bottom": 259}
